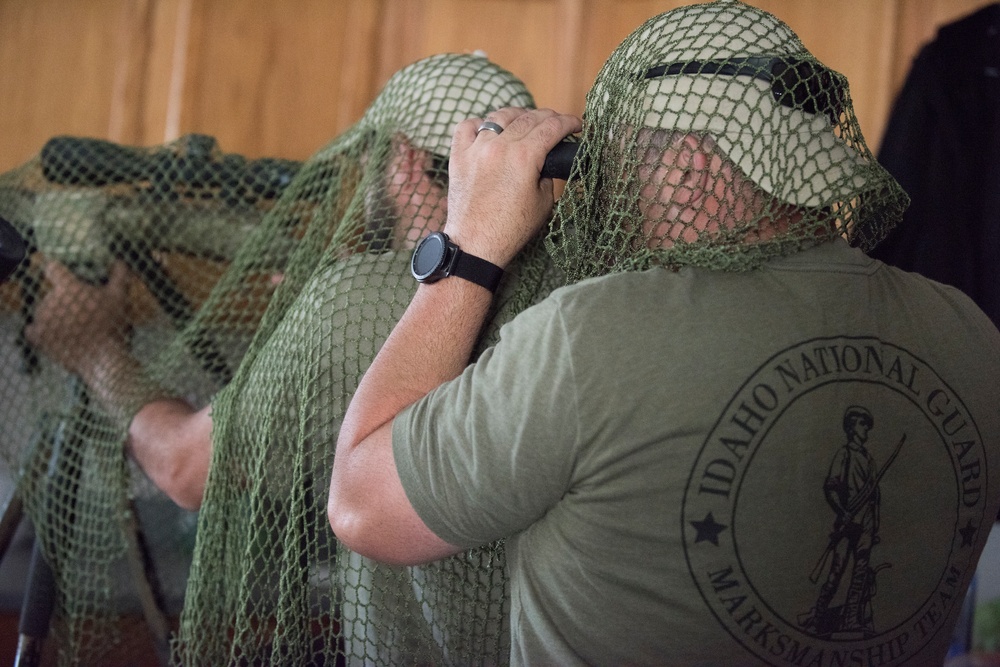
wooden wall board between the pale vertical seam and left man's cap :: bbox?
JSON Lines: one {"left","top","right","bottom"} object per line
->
{"left": 171, "top": 0, "right": 380, "bottom": 159}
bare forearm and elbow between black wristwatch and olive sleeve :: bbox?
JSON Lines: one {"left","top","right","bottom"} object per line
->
{"left": 327, "top": 278, "right": 492, "bottom": 565}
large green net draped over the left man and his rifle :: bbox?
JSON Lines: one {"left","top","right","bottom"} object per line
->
{"left": 0, "top": 55, "right": 564, "bottom": 665}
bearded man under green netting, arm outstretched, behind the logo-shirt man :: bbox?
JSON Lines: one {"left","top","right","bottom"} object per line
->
{"left": 29, "top": 54, "right": 562, "bottom": 665}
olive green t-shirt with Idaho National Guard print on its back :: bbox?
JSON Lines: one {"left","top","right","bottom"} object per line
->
{"left": 393, "top": 241, "right": 1000, "bottom": 665}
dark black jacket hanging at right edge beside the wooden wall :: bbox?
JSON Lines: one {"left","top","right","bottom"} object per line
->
{"left": 871, "top": 3, "right": 1000, "bottom": 327}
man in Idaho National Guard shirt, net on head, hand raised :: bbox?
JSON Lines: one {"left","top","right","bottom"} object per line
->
{"left": 328, "top": 0, "right": 1000, "bottom": 665}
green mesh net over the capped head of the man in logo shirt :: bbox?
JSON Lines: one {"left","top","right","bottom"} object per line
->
{"left": 548, "top": 0, "right": 908, "bottom": 278}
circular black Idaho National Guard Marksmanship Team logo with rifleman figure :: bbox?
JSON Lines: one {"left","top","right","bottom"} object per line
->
{"left": 682, "top": 337, "right": 993, "bottom": 667}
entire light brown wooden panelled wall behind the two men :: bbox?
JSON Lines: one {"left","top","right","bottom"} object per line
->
{"left": 0, "top": 0, "right": 1000, "bottom": 171}
